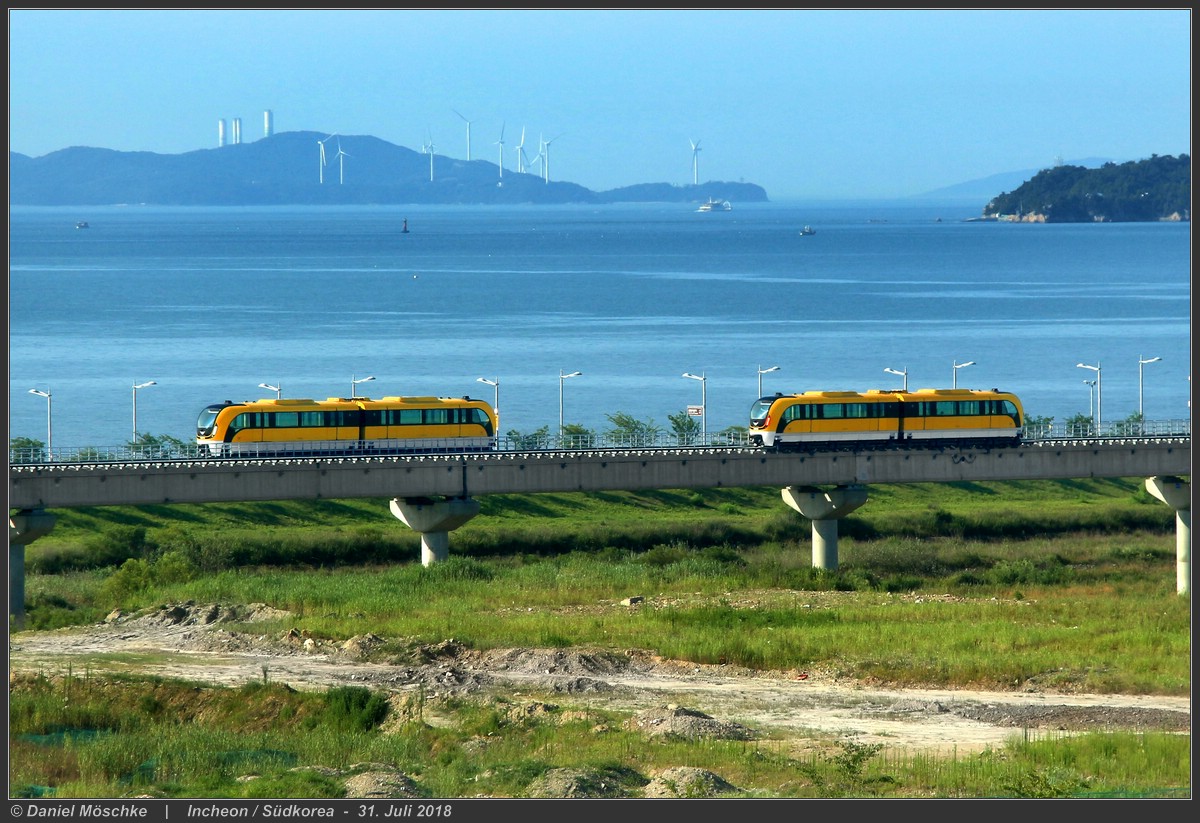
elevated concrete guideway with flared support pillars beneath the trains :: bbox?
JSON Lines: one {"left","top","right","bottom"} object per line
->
{"left": 8, "top": 435, "right": 1192, "bottom": 623}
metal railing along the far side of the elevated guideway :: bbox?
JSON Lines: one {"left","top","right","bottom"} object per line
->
{"left": 8, "top": 420, "right": 1192, "bottom": 465}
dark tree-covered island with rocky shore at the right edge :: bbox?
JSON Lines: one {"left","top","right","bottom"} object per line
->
{"left": 980, "top": 155, "right": 1192, "bottom": 223}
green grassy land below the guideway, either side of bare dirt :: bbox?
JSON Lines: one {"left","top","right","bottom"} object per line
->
{"left": 12, "top": 480, "right": 1190, "bottom": 797}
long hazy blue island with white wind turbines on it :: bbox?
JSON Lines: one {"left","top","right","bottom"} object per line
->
{"left": 8, "top": 131, "right": 768, "bottom": 206}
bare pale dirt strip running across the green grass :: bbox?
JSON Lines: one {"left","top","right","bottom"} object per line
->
{"left": 8, "top": 602, "right": 1190, "bottom": 755}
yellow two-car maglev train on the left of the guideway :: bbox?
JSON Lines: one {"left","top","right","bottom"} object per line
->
{"left": 196, "top": 397, "right": 496, "bottom": 456}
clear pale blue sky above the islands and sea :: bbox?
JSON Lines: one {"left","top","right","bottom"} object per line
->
{"left": 8, "top": 8, "right": 1192, "bottom": 200}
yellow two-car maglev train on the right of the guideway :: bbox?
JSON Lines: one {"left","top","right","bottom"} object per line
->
{"left": 750, "top": 389, "right": 1025, "bottom": 451}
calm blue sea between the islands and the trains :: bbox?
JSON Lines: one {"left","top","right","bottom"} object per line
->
{"left": 10, "top": 203, "right": 1192, "bottom": 449}
